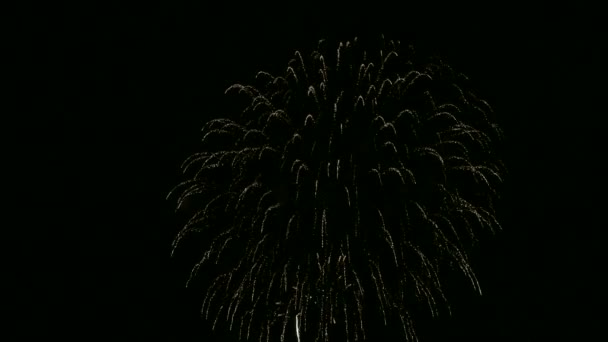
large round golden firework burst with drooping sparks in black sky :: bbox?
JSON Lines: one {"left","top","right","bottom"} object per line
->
{"left": 166, "top": 39, "right": 503, "bottom": 341}
